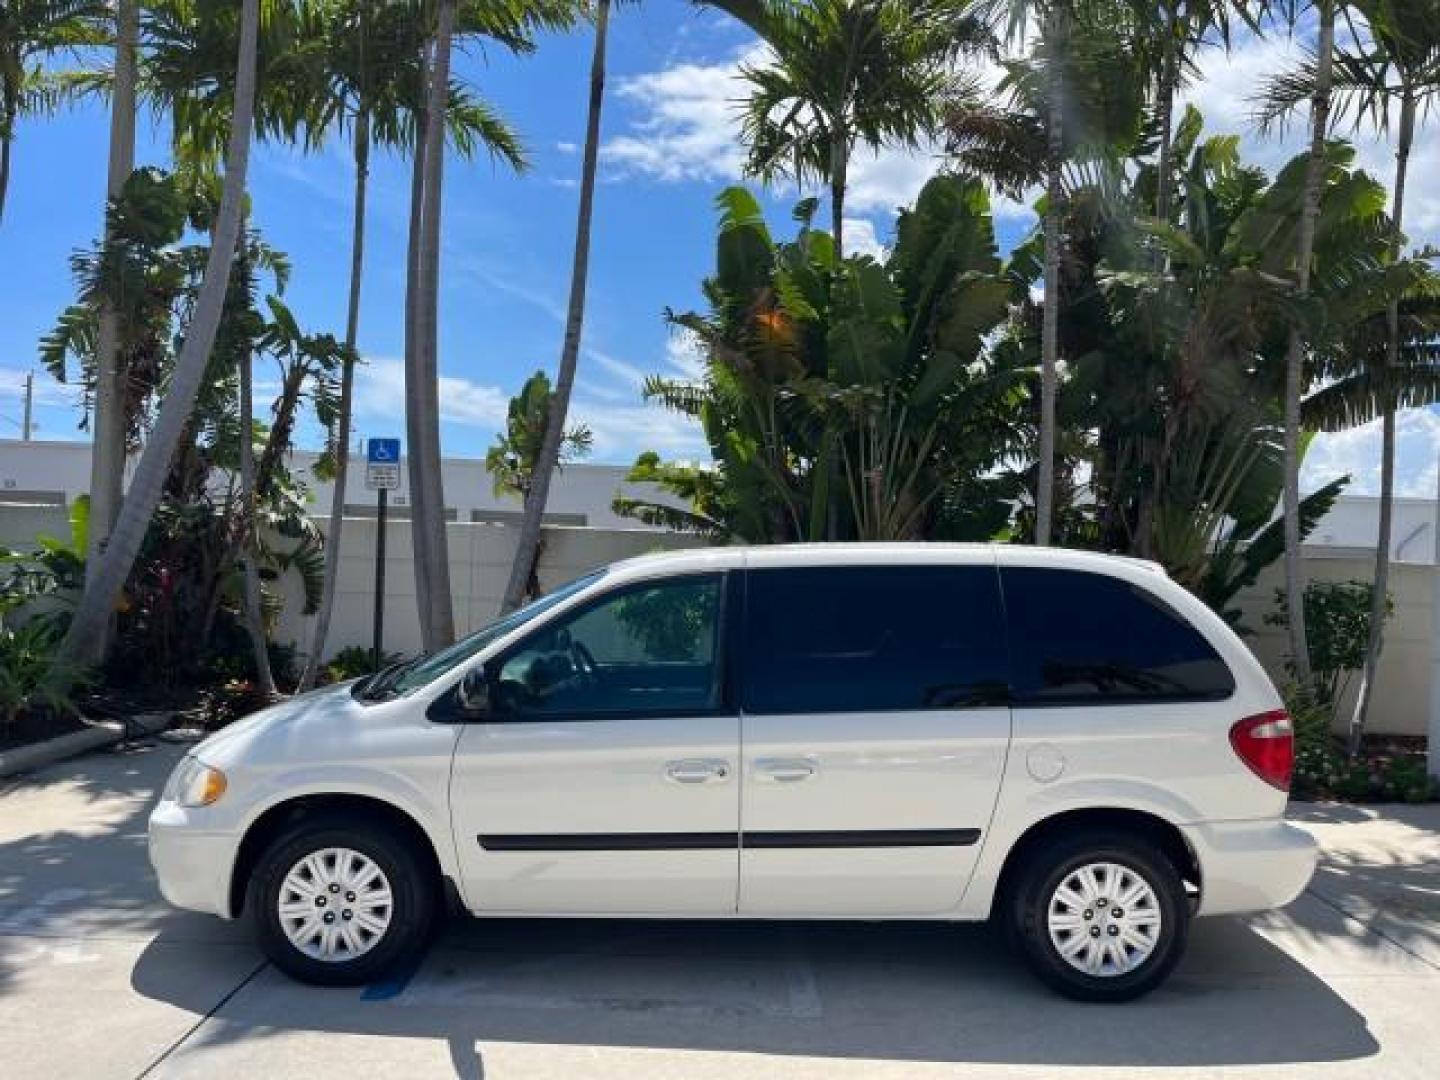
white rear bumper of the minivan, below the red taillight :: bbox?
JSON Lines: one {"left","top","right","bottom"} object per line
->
{"left": 1181, "top": 819, "right": 1318, "bottom": 914}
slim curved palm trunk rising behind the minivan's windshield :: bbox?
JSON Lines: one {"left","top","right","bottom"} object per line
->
{"left": 501, "top": 0, "right": 611, "bottom": 611}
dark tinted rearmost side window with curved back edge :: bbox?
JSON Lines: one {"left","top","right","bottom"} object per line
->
{"left": 1001, "top": 566, "right": 1236, "bottom": 706}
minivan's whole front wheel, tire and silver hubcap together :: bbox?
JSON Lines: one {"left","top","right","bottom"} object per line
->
{"left": 246, "top": 815, "right": 436, "bottom": 986}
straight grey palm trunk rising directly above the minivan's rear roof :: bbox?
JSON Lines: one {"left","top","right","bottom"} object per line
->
{"left": 1035, "top": 3, "right": 1067, "bottom": 546}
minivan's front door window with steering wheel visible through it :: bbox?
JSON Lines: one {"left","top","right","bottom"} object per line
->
{"left": 492, "top": 575, "right": 721, "bottom": 719}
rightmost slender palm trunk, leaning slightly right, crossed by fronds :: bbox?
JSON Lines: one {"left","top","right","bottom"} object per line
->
{"left": 1349, "top": 86, "right": 1416, "bottom": 757}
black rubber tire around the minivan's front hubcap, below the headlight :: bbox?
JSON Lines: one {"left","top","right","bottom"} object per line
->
{"left": 245, "top": 815, "right": 439, "bottom": 986}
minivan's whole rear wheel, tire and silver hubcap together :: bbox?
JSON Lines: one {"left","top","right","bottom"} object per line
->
{"left": 1009, "top": 832, "right": 1189, "bottom": 1001}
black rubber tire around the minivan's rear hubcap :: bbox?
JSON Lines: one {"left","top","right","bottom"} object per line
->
{"left": 1008, "top": 832, "right": 1189, "bottom": 1002}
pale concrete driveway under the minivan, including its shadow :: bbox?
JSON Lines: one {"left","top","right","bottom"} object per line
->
{"left": 0, "top": 743, "right": 1440, "bottom": 1080}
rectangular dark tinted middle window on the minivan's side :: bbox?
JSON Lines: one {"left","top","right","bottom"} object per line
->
{"left": 743, "top": 566, "right": 1005, "bottom": 713}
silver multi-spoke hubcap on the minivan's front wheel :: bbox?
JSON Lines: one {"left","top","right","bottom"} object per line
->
{"left": 276, "top": 848, "right": 395, "bottom": 962}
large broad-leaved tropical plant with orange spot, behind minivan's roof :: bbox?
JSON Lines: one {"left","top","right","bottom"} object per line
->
{"left": 615, "top": 176, "right": 1032, "bottom": 543}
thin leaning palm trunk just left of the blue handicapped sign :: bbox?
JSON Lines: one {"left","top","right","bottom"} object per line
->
{"left": 298, "top": 105, "right": 370, "bottom": 693}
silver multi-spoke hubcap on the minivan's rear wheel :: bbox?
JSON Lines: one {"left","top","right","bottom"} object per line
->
{"left": 1045, "top": 863, "right": 1161, "bottom": 978}
